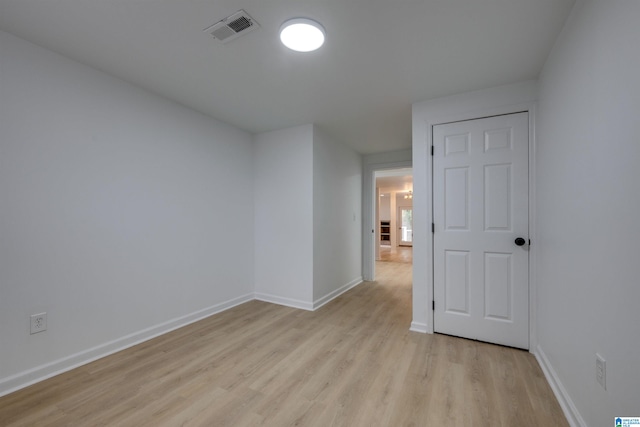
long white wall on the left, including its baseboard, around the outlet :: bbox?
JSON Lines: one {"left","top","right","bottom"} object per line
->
{"left": 0, "top": 32, "right": 254, "bottom": 394}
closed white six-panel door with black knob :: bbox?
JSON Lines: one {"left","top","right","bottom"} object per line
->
{"left": 433, "top": 113, "right": 529, "bottom": 349}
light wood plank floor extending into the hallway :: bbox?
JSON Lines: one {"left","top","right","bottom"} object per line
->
{"left": 0, "top": 262, "right": 567, "bottom": 427}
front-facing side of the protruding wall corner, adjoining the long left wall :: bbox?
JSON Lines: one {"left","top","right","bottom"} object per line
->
{"left": 254, "top": 125, "right": 314, "bottom": 309}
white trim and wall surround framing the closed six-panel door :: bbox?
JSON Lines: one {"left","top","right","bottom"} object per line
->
{"left": 410, "top": 81, "right": 537, "bottom": 352}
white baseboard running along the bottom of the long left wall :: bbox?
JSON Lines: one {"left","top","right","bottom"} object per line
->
{"left": 0, "top": 293, "right": 253, "bottom": 396}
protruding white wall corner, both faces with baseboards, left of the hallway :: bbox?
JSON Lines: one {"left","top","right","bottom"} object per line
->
{"left": 254, "top": 125, "right": 362, "bottom": 310}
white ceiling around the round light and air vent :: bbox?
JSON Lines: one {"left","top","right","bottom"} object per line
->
{"left": 0, "top": 0, "right": 575, "bottom": 154}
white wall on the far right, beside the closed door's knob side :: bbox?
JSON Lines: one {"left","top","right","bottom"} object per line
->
{"left": 537, "top": 0, "right": 640, "bottom": 427}
